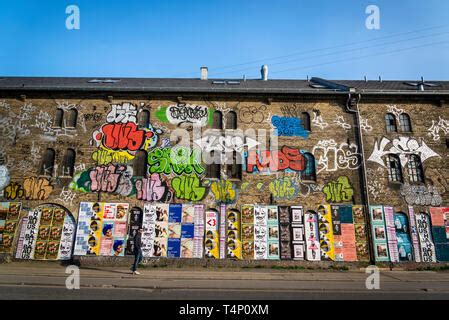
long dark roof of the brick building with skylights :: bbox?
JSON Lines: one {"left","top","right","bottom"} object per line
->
{"left": 0, "top": 77, "right": 449, "bottom": 95}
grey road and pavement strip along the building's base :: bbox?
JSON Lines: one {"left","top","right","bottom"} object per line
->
{"left": 0, "top": 263, "right": 449, "bottom": 300}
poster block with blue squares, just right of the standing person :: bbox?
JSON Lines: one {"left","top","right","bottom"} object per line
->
{"left": 142, "top": 203, "right": 204, "bottom": 258}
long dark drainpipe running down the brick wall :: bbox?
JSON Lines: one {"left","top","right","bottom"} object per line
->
{"left": 346, "top": 93, "right": 375, "bottom": 265}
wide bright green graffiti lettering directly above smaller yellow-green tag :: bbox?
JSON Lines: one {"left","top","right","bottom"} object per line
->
{"left": 148, "top": 147, "right": 205, "bottom": 175}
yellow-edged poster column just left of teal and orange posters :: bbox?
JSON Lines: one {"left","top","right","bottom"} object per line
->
{"left": 318, "top": 205, "right": 335, "bottom": 261}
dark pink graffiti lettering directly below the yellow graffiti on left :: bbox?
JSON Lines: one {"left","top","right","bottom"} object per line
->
{"left": 89, "top": 164, "right": 126, "bottom": 192}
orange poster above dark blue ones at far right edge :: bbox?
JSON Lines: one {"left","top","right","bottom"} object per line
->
{"left": 430, "top": 207, "right": 449, "bottom": 262}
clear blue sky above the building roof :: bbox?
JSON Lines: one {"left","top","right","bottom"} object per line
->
{"left": 0, "top": 0, "right": 449, "bottom": 80}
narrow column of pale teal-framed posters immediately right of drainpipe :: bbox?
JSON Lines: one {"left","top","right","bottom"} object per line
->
{"left": 370, "top": 206, "right": 390, "bottom": 261}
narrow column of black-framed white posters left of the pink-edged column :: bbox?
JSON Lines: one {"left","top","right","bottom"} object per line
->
{"left": 285, "top": 206, "right": 309, "bottom": 260}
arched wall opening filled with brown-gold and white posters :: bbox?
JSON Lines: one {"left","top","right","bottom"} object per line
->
{"left": 16, "top": 204, "right": 76, "bottom": 260}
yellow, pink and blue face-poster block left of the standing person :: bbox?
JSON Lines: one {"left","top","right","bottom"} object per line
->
{"left": 74, "top": 202, "right": 129, "bottom": 257}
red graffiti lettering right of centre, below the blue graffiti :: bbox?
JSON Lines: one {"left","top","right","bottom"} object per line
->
{"left": 246, "top": 146, "right": 306, "bottom": 173}
